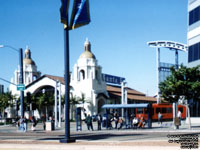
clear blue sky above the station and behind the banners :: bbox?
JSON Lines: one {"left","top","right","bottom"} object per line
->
{"left": 0, "top": 0, "right": 188, "bottom": 96}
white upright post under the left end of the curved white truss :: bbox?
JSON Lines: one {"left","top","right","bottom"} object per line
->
{"left": 156, "top": 48, "right": 160, "bottom": 104}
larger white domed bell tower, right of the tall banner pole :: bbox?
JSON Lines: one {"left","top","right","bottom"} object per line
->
{"left": 70, "top": 39, "right": 109, "bottom": 115}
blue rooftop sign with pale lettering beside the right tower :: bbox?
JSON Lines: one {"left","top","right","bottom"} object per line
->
{"left": 102, "top": 74, "right": 125, "bottom": 85}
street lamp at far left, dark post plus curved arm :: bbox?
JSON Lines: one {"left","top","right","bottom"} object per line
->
{"left": 0, "top": 45, "right": 24, "bottom": 118}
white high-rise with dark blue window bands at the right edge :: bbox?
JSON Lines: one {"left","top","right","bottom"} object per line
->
{"left": 187, "top": 0, "right": 200, "bottom": 67}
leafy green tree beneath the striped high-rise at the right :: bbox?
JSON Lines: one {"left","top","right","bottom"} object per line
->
{"left": 159, "top": 65, "right": 200, "bottom": 103}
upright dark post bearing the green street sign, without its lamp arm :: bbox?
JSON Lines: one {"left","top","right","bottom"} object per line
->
{"left": 19, "top": 48, "right": 24, "bottom": 118}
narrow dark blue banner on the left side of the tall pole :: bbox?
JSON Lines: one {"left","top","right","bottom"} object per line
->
{"left": 60, "top": 0, "right": 69, "bottom": 25}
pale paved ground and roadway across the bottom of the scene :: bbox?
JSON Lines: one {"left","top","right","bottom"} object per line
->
{"left": 0, "top": 122, "right": 200, "bottom": 150}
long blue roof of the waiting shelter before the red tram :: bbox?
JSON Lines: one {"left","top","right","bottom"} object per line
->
{"left": 102, "top": 104, "right": 149, "bottom": 109}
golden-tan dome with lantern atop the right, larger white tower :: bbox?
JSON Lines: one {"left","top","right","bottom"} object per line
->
{"left": 80, "top": 39, "right": 96, "bottom": 59}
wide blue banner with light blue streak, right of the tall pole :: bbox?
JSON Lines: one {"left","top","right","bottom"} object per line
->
{"left": 70, "top": 0, "right": 90, "bottom": 29}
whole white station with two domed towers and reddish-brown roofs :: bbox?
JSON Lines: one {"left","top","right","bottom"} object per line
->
{"left": 10, "top": 39, "right": 156, "bottom": 119}
